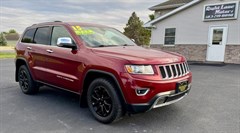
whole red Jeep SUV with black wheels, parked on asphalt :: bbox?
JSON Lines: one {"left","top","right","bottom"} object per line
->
{"left": 15, "top": 21, "right": 192, "bottom": 123}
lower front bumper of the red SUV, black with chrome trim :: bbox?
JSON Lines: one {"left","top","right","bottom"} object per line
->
{"left": 127, "top": 84, "right": 191, "bottom": 113}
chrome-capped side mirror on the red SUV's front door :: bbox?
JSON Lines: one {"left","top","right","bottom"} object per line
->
{"left": 57, "top": 37, "right": 77, "bottom": 50}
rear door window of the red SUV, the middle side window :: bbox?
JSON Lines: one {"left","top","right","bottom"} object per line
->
{"left": 34, "top": 27, "right": 50, "bottom": 45}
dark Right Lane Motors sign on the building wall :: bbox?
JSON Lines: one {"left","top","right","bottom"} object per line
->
{"left": 203, "top": 1, "right": 239, "bottom": 21}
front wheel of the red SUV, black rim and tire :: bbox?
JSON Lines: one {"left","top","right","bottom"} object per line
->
{"left": 87, "top": 78, "right": 124, "bottom": 124}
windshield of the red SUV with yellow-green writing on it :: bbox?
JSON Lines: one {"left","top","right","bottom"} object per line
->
{"left": 72, "top": 26, "right": 135, "bottom": 47}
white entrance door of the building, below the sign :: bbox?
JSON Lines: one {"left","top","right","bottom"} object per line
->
{"left": 207, "top": 26, "right": 228, "bottom": 62}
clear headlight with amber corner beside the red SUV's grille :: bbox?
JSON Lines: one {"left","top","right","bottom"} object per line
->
{"left": 125, "top": 65, "right": 154, "bottom": 74}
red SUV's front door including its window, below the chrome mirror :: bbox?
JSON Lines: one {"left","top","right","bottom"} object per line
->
{"left": 42, "top": 26, "right": 82, "bottom": 92}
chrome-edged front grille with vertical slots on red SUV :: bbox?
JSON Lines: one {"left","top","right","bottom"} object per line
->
{"left": 159, "top": 62, "right": 190, "bottom": 79}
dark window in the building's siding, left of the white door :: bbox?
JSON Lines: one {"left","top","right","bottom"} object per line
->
{"left": 164, "top": 28, "right": 176, "bottom": 45}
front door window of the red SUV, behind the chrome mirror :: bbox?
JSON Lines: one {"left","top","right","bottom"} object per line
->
{"left": 51, "top": 26, "right": 74, "bottom": 46}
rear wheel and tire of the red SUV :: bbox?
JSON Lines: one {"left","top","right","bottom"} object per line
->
{"left": 18, "top": 65, "right": 39, "bottom": 94}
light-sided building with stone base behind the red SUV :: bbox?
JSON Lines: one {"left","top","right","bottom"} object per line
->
{"left": 144, "top": 0, "right": 240, "bottom": 64}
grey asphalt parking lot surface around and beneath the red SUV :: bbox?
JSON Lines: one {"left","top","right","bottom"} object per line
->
{"left": 0, "top": 59, "right": 240, "bottom": 133}
